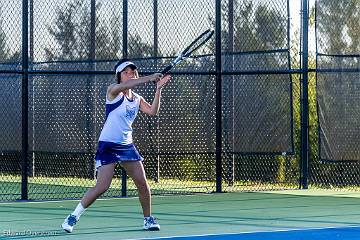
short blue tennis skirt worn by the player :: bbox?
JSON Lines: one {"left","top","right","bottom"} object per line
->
{"left": 95, "top": 141, "right": 144, "bottom": 168}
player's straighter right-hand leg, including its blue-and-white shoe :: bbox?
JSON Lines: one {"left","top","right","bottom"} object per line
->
{"left": 121, "top": 161, "right": 160, "bottom": 230}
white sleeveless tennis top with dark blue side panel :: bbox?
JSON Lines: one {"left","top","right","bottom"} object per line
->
{"left": 99, "top": 92, "right": 140, "bottom": 145}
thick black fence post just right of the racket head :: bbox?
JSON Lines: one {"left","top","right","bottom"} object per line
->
{"left": 215, "top": 0, "right": 222, "bottom": 193}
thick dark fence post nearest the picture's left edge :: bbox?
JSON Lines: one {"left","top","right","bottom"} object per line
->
{"left": 21, "top": 0, "right": 29, "bottom": 200}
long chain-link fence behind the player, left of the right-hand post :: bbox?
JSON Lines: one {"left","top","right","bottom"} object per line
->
{"left": 0, "top": 0, "right": 359, "bottom": 200}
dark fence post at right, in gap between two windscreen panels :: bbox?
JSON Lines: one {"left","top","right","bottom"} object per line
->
{"left": 300, "top": 0, "right": 309, "bottom": 189}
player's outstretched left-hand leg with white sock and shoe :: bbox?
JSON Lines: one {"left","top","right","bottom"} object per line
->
{"left": 61, "top": 163, "right": 115, "bottom": 232}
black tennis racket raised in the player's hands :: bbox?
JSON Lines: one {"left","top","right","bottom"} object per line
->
{"left": 161, "top": 29, "right": 215, "bottom": 75}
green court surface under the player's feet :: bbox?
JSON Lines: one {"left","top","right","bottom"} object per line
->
{"left": 0, "top": 190, "right": 360, "bottom": 240}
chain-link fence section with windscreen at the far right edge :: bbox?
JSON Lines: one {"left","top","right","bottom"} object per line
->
{"left": 310, "top": 0, "right": 360, "bottom": 190}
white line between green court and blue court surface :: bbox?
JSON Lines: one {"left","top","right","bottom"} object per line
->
{"left": 124, "top": 225, "right": 360, "bottom": 240}
